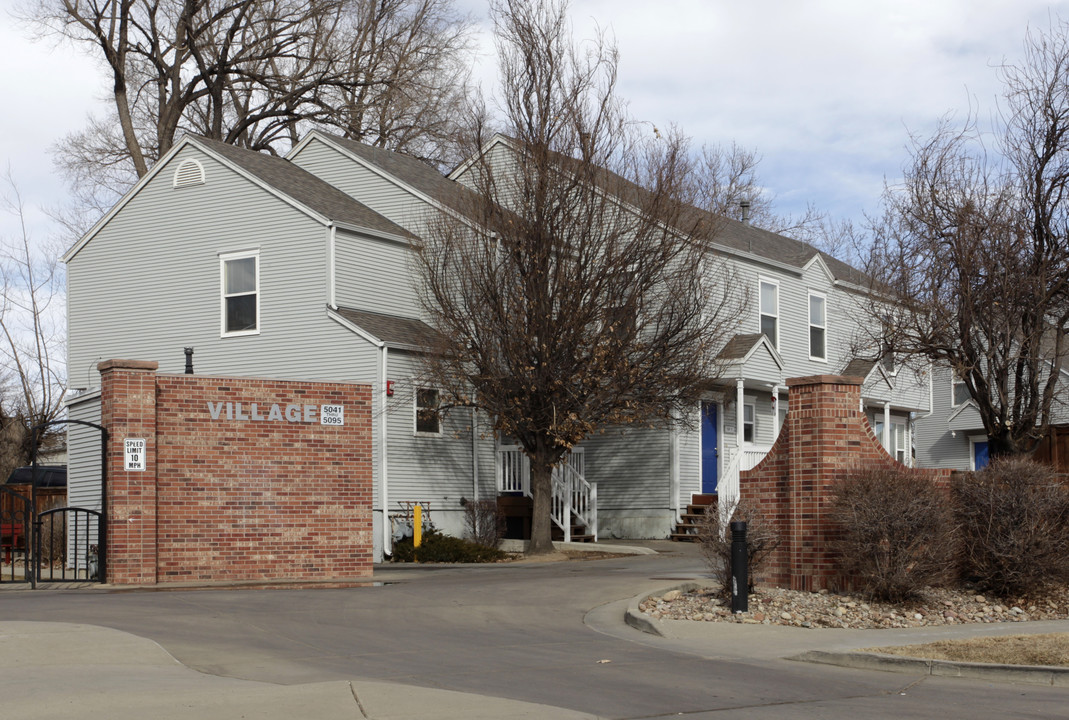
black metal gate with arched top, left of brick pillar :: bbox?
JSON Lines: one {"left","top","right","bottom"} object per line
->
{"left": 0, "top": 420, "right": 108, "bottom": 588}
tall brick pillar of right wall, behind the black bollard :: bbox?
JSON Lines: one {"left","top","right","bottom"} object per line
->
{"left": 787, "top": 375, "right": 864, "bottom": 591}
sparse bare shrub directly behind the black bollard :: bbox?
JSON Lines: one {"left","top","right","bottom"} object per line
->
{"left": 698, "top": 500, "right": 783, "bottom": 600}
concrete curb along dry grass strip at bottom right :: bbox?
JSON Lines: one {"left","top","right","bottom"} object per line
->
{"left": 787, "top": 651, "right": 1069, "bottom": 688}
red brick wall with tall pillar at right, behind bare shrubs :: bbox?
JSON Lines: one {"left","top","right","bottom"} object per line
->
{"left": 740, "top": 375, "right": 950, "bottom": 591}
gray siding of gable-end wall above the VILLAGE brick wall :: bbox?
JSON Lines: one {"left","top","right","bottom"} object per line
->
{"left": 67, "top": 142, "right": 374, "bottom": 387}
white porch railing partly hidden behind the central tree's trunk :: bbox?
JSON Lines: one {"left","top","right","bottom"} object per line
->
{"left": 497, "top": 445, "right": 598, "bottom": 543}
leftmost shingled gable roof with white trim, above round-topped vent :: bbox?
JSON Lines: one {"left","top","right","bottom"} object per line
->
{"left": 61, "top": 135, "right": 414, "bottom": 263}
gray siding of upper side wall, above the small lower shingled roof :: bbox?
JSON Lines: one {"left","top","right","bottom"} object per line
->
{"left": 335, "top": 225, "right": 419, "bottom": 317}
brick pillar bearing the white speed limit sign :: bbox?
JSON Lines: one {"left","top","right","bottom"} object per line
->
{"left": 96, "top": 360, "right": 159, "bottom": 584}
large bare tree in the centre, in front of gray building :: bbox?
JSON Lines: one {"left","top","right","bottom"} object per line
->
{"left": 417, "top": 0, "right": 741, "bottom": 553}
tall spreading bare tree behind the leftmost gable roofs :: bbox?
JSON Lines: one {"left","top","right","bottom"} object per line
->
{"left": 26, "top": 0, "right": 469, "bottom": 216}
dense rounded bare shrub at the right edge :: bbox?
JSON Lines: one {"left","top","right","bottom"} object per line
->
{"left": 954, "top": 458, "right": 1069, "bottom": 596}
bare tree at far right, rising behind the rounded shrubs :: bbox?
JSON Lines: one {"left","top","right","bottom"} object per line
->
{"left": 869, "top": 22, "right": 1069, "bottom": 455}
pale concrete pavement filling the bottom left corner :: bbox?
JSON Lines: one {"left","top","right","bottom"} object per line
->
{"left": 0, "top": 622, "right": 593, "bottom": 720}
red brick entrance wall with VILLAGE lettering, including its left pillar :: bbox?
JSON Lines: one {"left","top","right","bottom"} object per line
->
{"left": 99, "top": 360, "right": 372, "bottom": 584}
